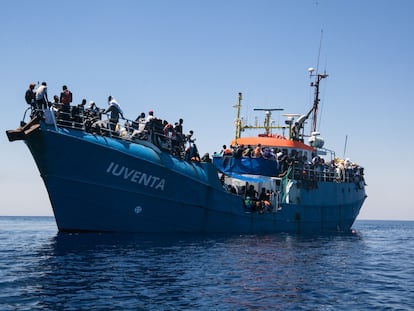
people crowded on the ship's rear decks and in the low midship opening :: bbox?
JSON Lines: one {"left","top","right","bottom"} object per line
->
{"left": 215, "top": 144, "right": 364, "bottom": 213}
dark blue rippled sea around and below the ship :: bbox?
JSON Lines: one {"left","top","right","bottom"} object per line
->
{"left": 0, "top": 217, "right": 414, "bottom": 310}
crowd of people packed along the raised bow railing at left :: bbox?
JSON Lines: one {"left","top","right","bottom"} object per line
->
{"left": 25, "top": 82, "right": 202, "bottom": 162}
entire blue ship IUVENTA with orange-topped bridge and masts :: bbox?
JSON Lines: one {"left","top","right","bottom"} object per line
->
{"left": 6, "top": 71, "right": 367, "bottom": 234}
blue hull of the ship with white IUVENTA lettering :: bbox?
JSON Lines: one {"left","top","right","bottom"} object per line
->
{"left": 17, "top": 122, "right": 366, "bottom": 233}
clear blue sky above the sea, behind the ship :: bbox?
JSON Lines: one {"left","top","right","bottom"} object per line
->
{"left": 0, "top": 0, "right": 414, "bottom": 220}
